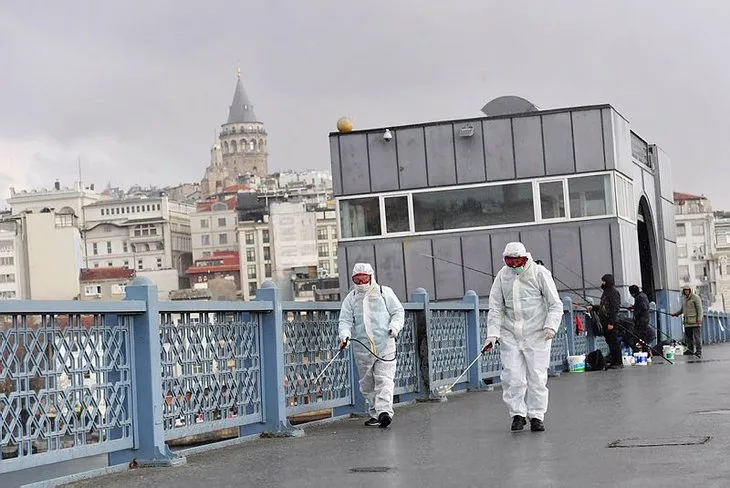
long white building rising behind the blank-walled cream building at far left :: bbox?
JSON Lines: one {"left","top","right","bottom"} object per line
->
{"left": 7, "top": 181, "right": 101, "bottom": 226}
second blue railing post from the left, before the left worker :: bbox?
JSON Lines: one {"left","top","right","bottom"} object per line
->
{"left": 256, "top": 281, "right": 304, "bottom": 437}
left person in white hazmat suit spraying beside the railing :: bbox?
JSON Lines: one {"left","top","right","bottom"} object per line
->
{"left": 339, "top": 263, "right": 405, "bottom": 428}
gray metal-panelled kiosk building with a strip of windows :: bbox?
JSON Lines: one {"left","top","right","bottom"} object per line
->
{"left": 329, "top": 96, "right": 679, "bottom": 332}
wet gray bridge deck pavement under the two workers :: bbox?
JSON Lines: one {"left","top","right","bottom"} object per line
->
{"left": 65, "top": 345, "right": 730, "bottom": 488}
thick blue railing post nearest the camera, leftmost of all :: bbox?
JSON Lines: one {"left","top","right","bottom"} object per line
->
{"left": 109, "top": 276, "right": 185, "bottom": 466}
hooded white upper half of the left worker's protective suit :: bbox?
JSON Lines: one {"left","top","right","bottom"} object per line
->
{"left": 339, "top": 263, "right": 405, "bottom": 359}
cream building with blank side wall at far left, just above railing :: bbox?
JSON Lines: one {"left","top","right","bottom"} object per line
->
{"left": 0, "top": 211, "right": 81, "bottom": 300}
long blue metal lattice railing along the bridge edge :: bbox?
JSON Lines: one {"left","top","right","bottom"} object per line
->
{"left": 0, "top": 279, "right": 730, "bottom": 473}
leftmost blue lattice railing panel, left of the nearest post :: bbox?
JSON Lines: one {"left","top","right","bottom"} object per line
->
{"left": 0, "top": 301, "right": 145, "bottom": 473}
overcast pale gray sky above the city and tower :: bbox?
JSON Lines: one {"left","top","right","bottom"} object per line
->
{"left": 0, "top": 0, "right": 730, "bottom": 209}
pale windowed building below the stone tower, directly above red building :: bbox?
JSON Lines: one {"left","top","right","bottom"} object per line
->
{"left": 190, "top": 197, "right": 238, "bottom": 261}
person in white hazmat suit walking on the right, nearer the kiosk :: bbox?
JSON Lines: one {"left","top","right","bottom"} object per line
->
{"left": 484, "top": 242, "right": 563, "bottom": 432}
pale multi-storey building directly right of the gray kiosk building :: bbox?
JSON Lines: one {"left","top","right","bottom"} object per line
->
{"left": 674, "top": 192, "right": 723, "bottom": 310}
